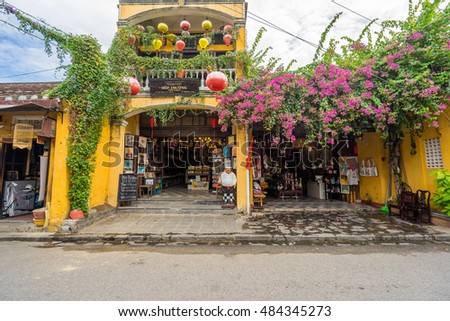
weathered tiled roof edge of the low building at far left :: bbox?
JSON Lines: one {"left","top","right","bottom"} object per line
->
{"left": 0, "top": 82, "right": 59, "bottom": 112}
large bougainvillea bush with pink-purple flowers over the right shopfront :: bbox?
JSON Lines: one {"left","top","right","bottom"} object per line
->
{"left": 218, "top": 1, "right": 450, "bottom": 148}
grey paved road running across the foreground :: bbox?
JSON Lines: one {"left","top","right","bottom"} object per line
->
{"left": 0, "top": 242, "right": 450, "bottom": 301}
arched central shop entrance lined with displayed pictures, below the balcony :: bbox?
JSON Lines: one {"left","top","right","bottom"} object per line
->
{"left": 124, "top": 110, "right": 234, "bottom": 203}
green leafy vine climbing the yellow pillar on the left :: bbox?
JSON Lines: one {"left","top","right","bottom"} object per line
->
{"left": 0, "top": 5, "right": 126, "bottom": 213}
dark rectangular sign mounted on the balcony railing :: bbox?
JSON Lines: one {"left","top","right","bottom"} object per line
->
{"left": 149, "top": 78, "right": 200, "bottom": 97}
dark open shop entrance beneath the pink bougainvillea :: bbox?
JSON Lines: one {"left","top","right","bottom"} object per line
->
{"left": 252, "top": 126, "right": 359, "bottom": 207}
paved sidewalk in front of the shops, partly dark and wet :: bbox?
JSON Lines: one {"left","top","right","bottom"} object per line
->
{"left": 0, "top": 201, "right": 450, "bottom": 245}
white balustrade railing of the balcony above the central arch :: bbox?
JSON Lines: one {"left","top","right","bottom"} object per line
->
{"left": 138, "top": 68, "right": 236, "bottom": 93}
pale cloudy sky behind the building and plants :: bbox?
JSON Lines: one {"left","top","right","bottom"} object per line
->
{"left": 0, "top": 0, "right": 442, "bottom": 83}
